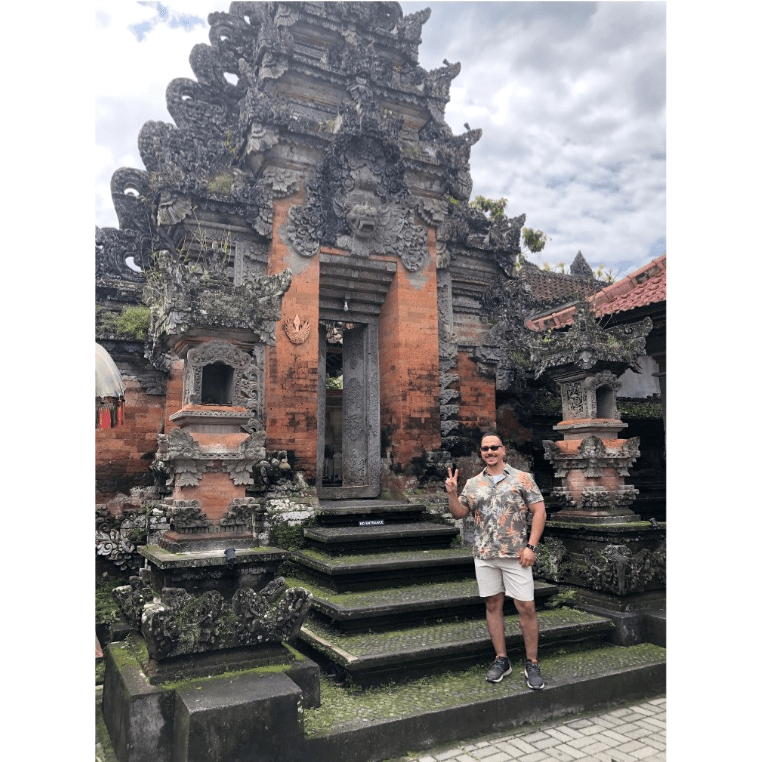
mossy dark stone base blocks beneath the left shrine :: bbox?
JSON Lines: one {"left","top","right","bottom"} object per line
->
{"left": 103, "top": 634, "right": 320, "bottom": 762}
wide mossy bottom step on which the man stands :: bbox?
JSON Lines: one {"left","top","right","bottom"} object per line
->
{"left": 294, "top": 643, "right": 666, "bottom": 762}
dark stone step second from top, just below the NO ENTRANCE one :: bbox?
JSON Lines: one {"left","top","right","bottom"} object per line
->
{"left": 304, "top": 521, "right": 460, "bottom": 554}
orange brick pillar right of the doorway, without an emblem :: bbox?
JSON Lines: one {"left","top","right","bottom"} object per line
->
{"left": 378, "top": 231, "right": 441, "bottom": 466}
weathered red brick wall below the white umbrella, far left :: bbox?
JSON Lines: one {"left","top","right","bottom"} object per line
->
{"left": 95, "top": 380, "right": 164, "bottom": 504}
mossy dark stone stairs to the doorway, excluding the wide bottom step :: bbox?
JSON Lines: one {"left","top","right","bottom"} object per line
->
{"left": 287, "top": 500, "right": 660, "bottom": 688}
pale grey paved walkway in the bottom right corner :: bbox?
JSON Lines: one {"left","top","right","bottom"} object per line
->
{"left": 406, "top": 697, "right": 666, "bottom": 762}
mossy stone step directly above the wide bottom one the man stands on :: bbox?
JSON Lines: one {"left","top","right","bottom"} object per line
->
{"left": 297, "top": 608, "right": 614, "bottom": 685}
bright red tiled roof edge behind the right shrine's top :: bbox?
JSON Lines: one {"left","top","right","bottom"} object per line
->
{"left": 526, "top": 254, "right": 666, "bottom": 331}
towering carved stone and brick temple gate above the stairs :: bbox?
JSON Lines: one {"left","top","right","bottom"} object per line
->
{"left": 96, "top": 2, "right": 524, "bottom": 498}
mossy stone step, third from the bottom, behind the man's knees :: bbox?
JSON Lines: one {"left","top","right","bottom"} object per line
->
{"left": 294, "top": 577, "right": 558, "bottom": 632}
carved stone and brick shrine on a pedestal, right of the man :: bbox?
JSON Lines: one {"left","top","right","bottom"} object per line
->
{"left": 531, "top": 301, "right": 666, "bottom": 632}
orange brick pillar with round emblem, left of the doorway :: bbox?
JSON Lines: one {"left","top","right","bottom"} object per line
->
{"left": 265, "top": 190, "right": 320, "bottom": 479}
